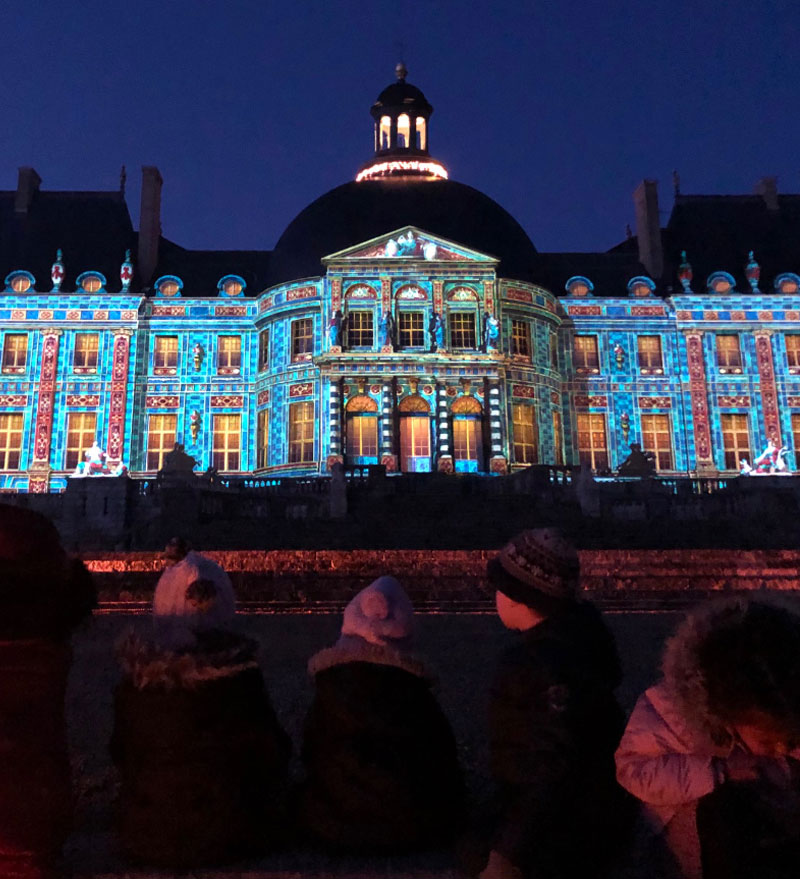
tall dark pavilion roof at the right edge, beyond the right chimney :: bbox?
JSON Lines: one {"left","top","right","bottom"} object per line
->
{"left": 661, "top": 195, "right": 800, "bottom": 293}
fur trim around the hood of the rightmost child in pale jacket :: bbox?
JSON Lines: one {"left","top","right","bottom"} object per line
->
{"left": 662, "top": 596, "right": 797, "bottom": 747}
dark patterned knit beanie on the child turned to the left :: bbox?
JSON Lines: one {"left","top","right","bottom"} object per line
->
{"left": 490, "top": 528, "right": 580, "bottom": 604}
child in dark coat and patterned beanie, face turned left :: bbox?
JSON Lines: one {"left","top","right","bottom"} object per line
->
{"left": 480, "top": 529, "right": 630, "bottom": 879}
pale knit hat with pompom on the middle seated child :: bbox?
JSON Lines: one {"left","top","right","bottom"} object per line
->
{"left": 340, "top": 576, "right": 414, "bottom": 647}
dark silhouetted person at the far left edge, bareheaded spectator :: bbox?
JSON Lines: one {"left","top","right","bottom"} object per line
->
{"left": 0, "top": 504, "right": 96, "bottom": 877}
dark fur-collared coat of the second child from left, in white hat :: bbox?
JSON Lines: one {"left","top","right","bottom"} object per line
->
{"left": 111, "top": 632, "right": 291, "bottom": 867}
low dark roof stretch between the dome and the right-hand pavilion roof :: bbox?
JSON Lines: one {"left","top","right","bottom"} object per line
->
{"left": 534, "top": 247, "right": 647, "bottom": 296}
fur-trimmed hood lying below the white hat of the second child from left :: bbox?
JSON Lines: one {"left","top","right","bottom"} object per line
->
{"left": 117, "top": 630, "right": 258, "bottom": 690}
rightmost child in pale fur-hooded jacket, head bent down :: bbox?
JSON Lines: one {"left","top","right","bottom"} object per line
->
{"left": 616, "top": 598, "right": 800, "bottom": 879}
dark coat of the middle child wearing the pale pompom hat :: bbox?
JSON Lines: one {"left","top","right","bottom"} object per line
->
{"left": 300, "top": 638, "right": 464, "bottom": 851}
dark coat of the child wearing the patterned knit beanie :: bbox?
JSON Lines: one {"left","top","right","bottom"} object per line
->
{"left": 489, "top": 603, "right": 630, "bottom": 877}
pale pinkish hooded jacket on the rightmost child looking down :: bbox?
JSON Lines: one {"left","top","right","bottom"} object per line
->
{"left": 616, "top": 603, "right": 800, "bottom": 879}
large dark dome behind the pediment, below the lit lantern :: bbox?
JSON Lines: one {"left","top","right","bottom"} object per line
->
{"left": 270, "top": 178, "right": 536, "bottom": 284}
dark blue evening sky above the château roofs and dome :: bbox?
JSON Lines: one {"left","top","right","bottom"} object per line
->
{"left": 0, "top": 0, "right": 800, "bottom": 250}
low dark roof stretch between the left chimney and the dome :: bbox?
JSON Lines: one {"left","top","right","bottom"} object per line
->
{"left": 153, "top": 238, "right": 271, "bottom": 296}
